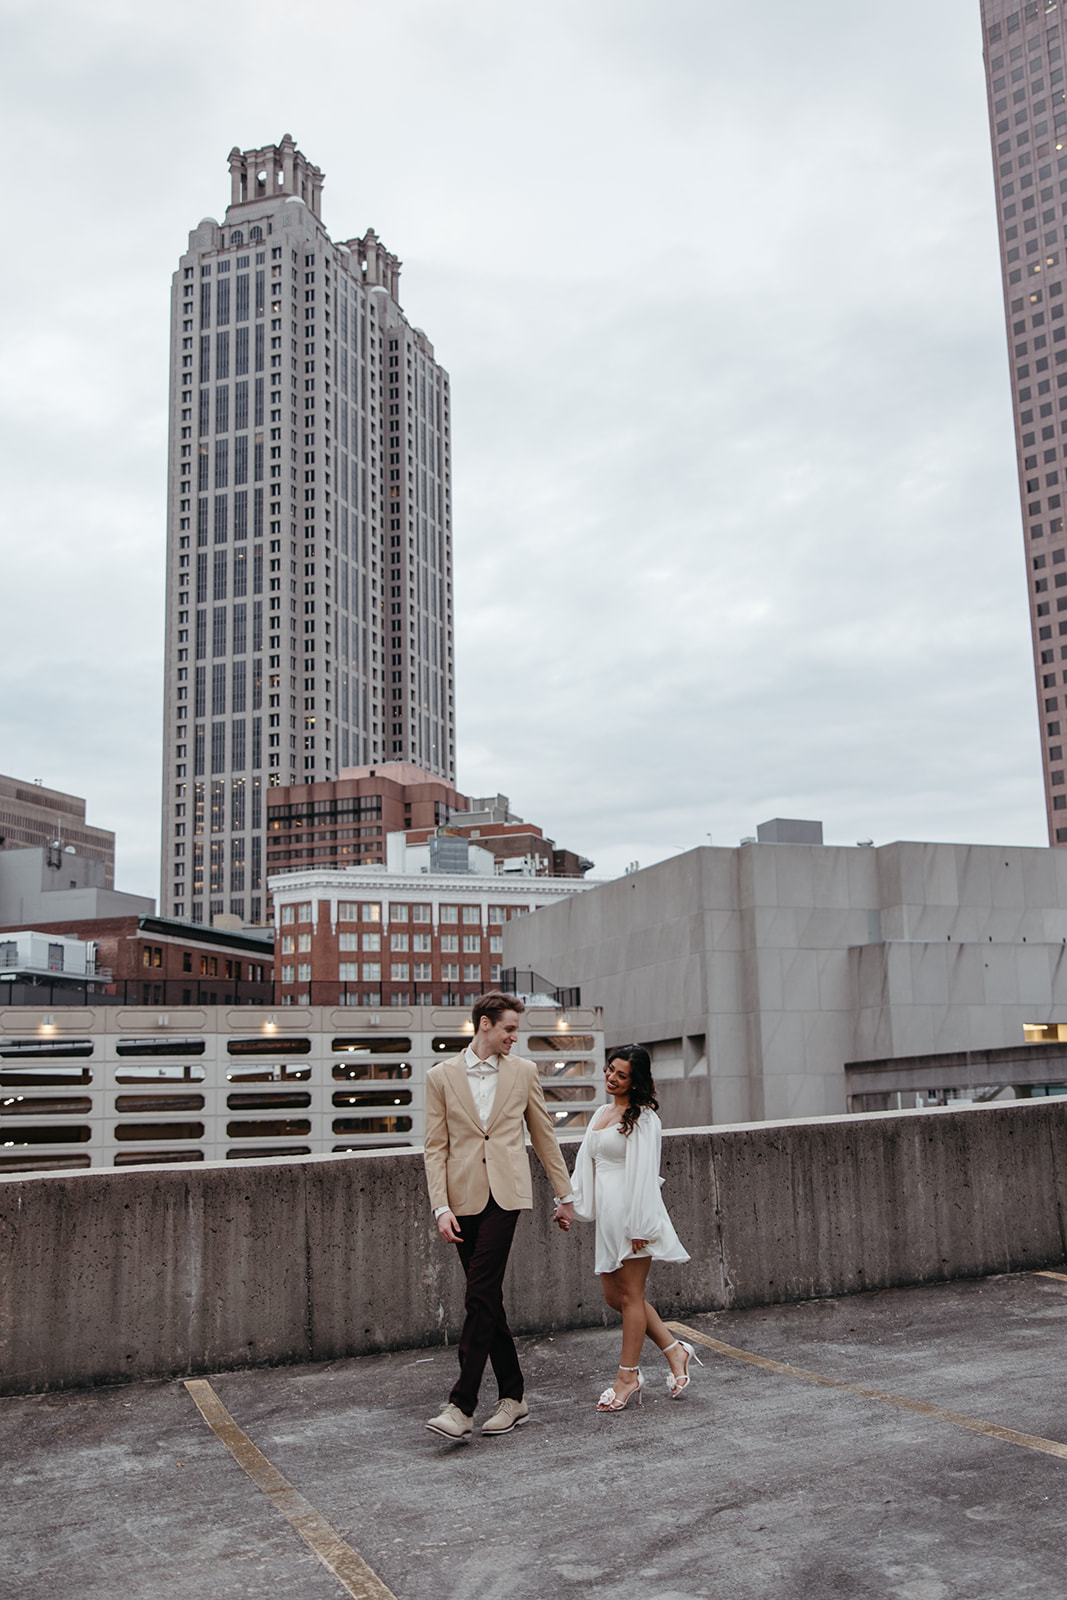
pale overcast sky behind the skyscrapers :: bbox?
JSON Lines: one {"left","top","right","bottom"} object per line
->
{"left": 0, "top": 0, "right": 1046, "bottom": 894}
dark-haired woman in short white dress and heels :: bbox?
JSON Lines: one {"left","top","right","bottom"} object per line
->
{"left": 573, "top": 1045, "right": 702, "bottom": 1411}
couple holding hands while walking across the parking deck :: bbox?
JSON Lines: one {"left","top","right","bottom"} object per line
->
{"left": 426, "top": 992, "right": 694, "bottom": 1440}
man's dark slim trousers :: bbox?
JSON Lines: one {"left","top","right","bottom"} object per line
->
{"left": 448, "top": 1197, "right": 523, "bottom": 1416}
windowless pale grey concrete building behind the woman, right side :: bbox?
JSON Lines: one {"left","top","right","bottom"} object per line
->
{"left": 504, "top": 842, "right": 1067, "bottom": 1126}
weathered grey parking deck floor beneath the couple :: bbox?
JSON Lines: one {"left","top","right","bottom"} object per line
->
{"left": 0, "top": 1274, "right": 1067, "bottom": 1600}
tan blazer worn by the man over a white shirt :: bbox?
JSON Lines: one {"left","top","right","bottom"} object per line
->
{"left": 424, "top": 1051, "right": 571, "bottom": 1216}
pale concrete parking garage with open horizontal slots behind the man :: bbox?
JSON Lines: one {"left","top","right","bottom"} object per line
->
{"left": 0, "top": 1005, "right": 605, "bottom": 1178}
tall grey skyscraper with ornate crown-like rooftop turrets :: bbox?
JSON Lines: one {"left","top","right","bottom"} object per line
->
{"left": 160, "top": 134, "right": 456, "bottom": 922}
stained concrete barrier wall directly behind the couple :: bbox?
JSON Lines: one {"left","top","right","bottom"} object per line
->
{"left": 0, "top": 1099, "right": 1067, "bottom": 1394}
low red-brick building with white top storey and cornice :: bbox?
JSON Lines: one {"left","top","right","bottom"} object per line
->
{"left": 270, "top": 870, "right": 601, "bottom": 1008}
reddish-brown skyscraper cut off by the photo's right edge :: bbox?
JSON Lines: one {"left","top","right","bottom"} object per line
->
{"left": 982, "top": 0, "right": 1067, "bottom": 845}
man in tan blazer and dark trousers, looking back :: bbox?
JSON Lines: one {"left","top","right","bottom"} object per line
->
{"left": 426, "top": 990, "right": 574, "bottom": 1438}
